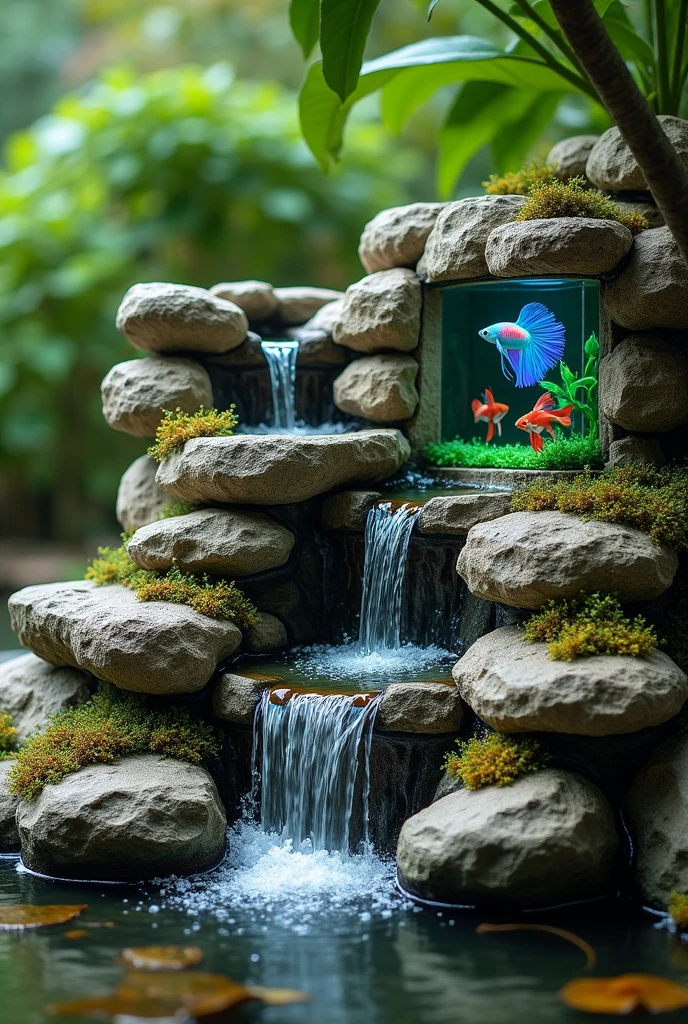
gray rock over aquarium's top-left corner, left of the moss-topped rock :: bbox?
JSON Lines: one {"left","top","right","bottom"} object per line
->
{"left": 419, "top": 196, "right": 525, "bottom": 282}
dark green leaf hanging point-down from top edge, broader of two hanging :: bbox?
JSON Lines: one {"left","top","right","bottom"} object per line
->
{"left": 320, "top": 0, "right": 380, "bottom": 103}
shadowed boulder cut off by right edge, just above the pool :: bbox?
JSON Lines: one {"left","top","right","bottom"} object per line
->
{"left": 627, "top": 736, "right": 688, "bottom": 910}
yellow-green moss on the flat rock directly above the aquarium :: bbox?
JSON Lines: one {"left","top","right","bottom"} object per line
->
{"left": 516, "top": 177, "right": 649, "bottom": 234}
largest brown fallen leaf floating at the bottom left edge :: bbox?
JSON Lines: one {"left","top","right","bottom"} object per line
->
{"left": 48, "top": 971, "right": 307, "bottom": 1024}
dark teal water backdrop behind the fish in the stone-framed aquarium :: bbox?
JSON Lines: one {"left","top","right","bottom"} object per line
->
{"left": 441, "top": 278, "right": 600, "bottom": 444}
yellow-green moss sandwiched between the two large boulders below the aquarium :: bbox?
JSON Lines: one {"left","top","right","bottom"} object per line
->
{"left": 523, "top": 594, "right": 657, "bottom": 662}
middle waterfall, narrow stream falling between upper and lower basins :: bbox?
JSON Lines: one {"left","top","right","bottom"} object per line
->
{"left": 358, "top": 504, "right": 421, "bottom": 654}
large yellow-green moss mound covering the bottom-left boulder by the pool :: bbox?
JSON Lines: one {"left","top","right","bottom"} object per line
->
{"left": 9, "top": 684, "right": 218, "bottom": 800}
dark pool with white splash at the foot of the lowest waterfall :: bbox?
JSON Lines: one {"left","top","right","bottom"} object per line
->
{"left": 0, "top": 847, "right": 688, "bottom": 1024}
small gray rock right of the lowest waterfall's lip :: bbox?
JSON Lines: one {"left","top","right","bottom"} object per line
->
{"left": 375, "top": 680, "right": 463, "bottom": 734}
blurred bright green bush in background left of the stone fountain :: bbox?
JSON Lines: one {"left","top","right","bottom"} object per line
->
{"left": 0, "top": 65, "right": 413, "bottom": 539}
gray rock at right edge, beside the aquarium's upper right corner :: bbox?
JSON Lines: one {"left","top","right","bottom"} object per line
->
{"left": 603, "top": 227, "right": 688, "bottom": 331}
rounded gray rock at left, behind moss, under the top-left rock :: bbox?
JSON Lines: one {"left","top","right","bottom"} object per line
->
{"left": 100, "top": 355, "right": 213, "bottom": 437}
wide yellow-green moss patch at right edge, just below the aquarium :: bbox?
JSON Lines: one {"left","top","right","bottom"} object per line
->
{"left": 511, "top": 465, "right": 688, "bottom": 550}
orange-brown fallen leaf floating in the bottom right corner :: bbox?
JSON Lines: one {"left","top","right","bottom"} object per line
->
{"left": 560, "top": 974, "right": 688, "bottom": 1016}
